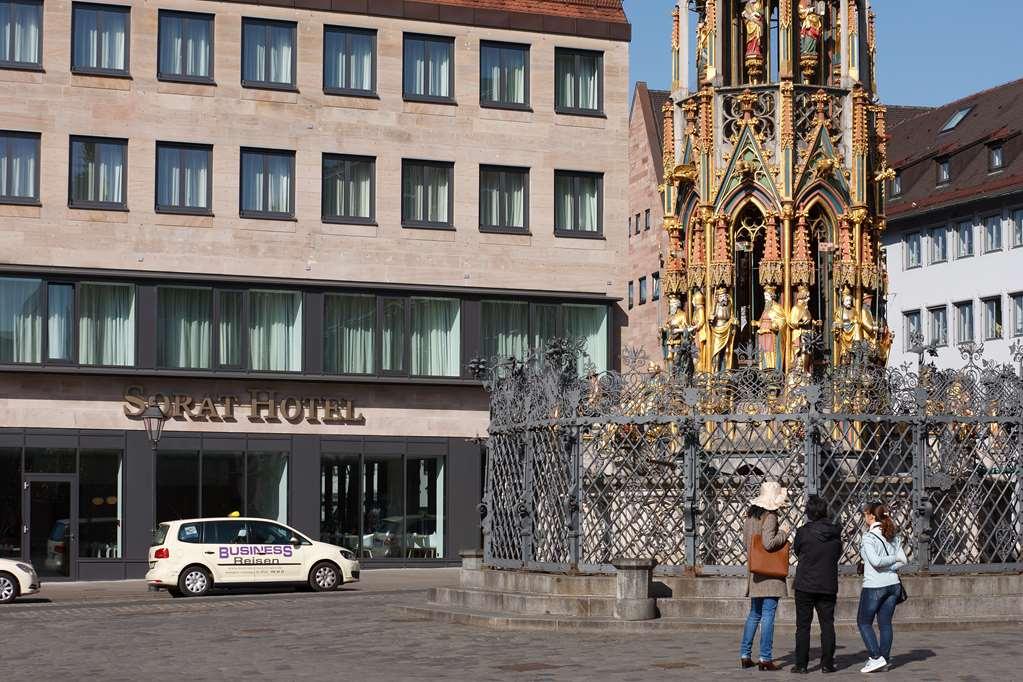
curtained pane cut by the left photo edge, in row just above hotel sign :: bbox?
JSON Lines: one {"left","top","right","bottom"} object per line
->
{"left": 0, "top": 277, "right": 43, "bottom": 363}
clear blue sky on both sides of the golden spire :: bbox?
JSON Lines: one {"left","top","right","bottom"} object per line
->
{"left": 625, "top": 0, "right": 1023, "bottom": 105}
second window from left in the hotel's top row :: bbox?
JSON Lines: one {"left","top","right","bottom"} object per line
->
{"left": 71, "top": 2, "right": 131, "bottom": 76}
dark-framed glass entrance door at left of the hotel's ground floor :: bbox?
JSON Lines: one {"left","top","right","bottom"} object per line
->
{"left": 21, "top": 475, "right": 78, "bottom": 580}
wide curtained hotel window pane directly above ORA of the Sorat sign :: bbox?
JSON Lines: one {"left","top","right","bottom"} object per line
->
{"left": 157, "top": 286, "right": 213, "bottom": 369}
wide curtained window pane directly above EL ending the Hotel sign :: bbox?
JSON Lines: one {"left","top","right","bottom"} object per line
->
{"left": 323, "top": 293, "right": 376, "bottom": 374}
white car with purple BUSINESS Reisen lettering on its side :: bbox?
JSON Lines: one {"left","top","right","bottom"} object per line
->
{"left": 145, "top": 517, "right": 359, "bottom": 596}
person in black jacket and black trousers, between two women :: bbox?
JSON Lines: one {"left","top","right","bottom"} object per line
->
{"left": 792, "top": 495, "right": 842, "bottom": 673}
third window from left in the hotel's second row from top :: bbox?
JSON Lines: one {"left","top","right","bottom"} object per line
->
{"left": 157, "top": 142, "right": 213, "bottom": 215}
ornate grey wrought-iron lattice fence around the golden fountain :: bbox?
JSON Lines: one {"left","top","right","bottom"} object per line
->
{"left": 474, "top": 342, "right": 1023, "bottom": 575}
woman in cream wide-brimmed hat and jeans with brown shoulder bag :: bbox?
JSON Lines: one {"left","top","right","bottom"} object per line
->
{"left": 739, "top": 481, "right": 789, "bottom": 671}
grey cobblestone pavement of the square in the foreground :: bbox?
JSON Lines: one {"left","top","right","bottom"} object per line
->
{"left": 0, "top": 571, "right": 1023, "bottom": 682}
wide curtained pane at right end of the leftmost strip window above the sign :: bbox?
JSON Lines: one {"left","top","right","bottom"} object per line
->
{"left": 78, "top": 282, "right": 135, "bottom": 367}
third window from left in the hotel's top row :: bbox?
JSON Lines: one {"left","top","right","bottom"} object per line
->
{"left": 157, "top": 9, "right": 214, "bottom": 83}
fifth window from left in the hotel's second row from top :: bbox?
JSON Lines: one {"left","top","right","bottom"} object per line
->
{"left": 322, "top": 154, "right": 376, "bottom": 223}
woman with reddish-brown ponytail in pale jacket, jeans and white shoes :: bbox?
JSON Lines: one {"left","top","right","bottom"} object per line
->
{"left": 856, "top": 502, "right": 908, "bottom": 673}
